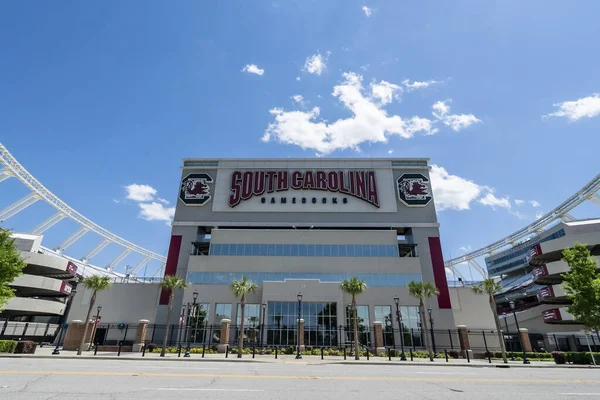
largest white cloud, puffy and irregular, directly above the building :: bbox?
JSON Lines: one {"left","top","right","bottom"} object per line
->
{"left": 262, "top": 72, "right": 436, "bottom": 154}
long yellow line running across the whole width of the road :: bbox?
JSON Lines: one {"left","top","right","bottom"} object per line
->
{"left": 0, "top": 371, "right": 600, "bottom": 383}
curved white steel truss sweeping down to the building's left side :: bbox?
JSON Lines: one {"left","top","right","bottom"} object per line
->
{"left": 0, "top": 143, "right": 167, "bottom": 263}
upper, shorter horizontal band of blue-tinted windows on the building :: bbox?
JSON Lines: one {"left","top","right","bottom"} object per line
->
{"left": 209, "top": 243, "right": 399, "bottom": 257}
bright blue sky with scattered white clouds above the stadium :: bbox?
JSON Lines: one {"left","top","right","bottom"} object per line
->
{"left": 0, "top": 0, "right": 600, "bottom": 273}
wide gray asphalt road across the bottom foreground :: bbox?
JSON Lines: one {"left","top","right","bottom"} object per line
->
{"left": 0, "top": 358, "right": 600, "bottom": 400}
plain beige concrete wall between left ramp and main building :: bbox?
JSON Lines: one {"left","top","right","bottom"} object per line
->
{"left": 68, "top": 283, "right": 159, "bottom": 325}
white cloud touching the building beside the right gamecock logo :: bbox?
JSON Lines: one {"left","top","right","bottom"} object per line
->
{"left": 429, "top": 165, "right": 485, "bottom": 211}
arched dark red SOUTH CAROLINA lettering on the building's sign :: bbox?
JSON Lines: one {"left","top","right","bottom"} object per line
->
{"left": 229, "top": 170, "right": 379, "bottom": 207}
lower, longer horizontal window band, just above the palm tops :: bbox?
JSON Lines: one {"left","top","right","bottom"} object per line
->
{"left": 187, "top": 272, "right": 421, "bottom": 287}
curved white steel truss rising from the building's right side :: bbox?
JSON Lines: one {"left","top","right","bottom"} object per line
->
{"left": 444, "top": 174, "right": 600, "bottom": 268}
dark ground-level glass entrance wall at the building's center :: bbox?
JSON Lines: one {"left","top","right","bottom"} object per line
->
{"left": 266, "top": 301, "right": 338, "bottom": 346}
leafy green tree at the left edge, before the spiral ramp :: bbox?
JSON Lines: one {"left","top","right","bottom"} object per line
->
{"left": 0, "top": 228, "right": 27, "bottom": 311}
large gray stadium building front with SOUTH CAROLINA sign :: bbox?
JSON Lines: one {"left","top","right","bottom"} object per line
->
{"left": 156, "top": 159, "right": 456, "bottom": 345}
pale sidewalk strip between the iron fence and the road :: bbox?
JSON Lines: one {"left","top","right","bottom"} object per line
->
{"left": 0, "top": 346, "right": 594, "bottom": 369}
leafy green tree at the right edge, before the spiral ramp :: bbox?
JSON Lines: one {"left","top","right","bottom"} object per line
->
{"left": 562, "top": 243, "right": 600, "bottom": 330}
